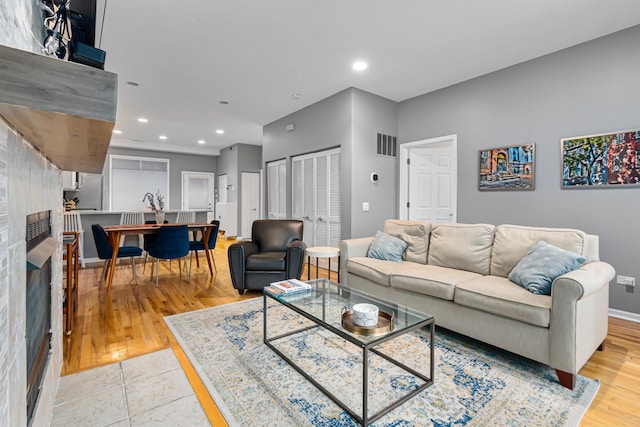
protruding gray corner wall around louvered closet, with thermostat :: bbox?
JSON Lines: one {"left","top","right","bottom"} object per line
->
{"left": 262, "top": 88, "right": 397, "bottom": 238}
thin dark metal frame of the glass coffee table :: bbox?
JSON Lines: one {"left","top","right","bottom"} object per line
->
{"left": 263, "top": 279, "right": 435, "bottom": 426}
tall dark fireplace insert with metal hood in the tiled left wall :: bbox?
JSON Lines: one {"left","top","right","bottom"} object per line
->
{"left": 25, "top": 211, "right": 60, "bottom": 424}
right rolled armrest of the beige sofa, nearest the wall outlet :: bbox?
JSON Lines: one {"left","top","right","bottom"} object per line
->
{"left": 549, "top": 261, "right": 615, "bottom": 374}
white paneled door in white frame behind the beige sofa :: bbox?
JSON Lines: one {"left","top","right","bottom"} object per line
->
{"left": 399, "top": 135, "right": 457, "bottom": 223}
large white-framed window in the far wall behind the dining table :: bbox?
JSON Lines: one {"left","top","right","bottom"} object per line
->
{"left": 109, "top": 155, "right": 169, "bottom": 212}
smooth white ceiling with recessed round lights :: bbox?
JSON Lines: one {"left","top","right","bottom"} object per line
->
{"left": 96, "top": 0, "right": 640, "bottom": 155}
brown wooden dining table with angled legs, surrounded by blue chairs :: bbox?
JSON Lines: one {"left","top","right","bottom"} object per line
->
{"left": 103, "top": 222, "right": 216, "bottom": 291}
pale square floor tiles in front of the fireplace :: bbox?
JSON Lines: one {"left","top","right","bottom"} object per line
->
{"left": 51, "top": 349, "right": 211, "bottom": 427}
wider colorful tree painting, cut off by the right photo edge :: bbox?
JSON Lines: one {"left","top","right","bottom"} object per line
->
{"left": 561, "top": 129, "right": 640, "bottom": 188}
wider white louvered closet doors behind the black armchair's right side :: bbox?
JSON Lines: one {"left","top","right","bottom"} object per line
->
{"left": 292, "top": 149, "right": 340, "bottom": 246}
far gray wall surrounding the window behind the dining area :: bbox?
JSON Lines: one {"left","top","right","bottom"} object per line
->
{"left": 71, "top": 147, "right": 217, "bottom": 210}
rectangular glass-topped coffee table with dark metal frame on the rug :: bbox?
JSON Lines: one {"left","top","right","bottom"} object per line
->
{"left": 263, "top": 279, "right": 435, "bottom": 426}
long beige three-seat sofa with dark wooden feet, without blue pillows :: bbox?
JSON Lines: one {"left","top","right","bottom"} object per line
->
{"left": 340, "top": 220, "right": 615, "bottom": 389}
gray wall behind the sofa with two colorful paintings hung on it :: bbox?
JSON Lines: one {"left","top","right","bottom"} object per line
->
{"left": 398, "top": 26, "right": 640, "bottom": 313}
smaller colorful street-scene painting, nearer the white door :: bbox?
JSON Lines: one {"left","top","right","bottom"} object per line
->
{"left": 479, "top": 144, "right": 536, "bottom": 191}
